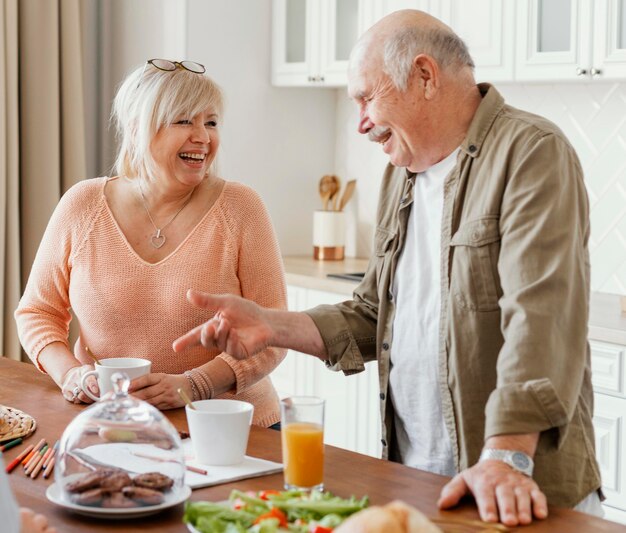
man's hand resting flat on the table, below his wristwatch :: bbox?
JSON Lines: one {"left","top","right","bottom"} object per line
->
{"left": 437, "top": 460, "right": 548, "bottom": 526}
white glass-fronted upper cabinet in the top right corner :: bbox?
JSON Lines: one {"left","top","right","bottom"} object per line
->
{"left": 515, "top": 0, "right": 626, "bottom": 81}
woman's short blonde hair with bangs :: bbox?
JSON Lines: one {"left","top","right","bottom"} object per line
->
{"left": 111, "top": 64, "right": 224, "bottom": 178}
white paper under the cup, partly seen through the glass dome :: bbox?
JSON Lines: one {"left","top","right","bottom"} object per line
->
{"left": 78, "top": 439, "right": 283, "bottom": 489}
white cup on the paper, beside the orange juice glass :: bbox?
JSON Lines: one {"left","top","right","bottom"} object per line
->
{"left": 185, "top": 400, "right": 254, "bottom": 466}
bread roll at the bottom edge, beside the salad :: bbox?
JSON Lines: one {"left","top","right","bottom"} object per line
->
{"left": 335, "top": 500, "right": 441, "bottom": 533}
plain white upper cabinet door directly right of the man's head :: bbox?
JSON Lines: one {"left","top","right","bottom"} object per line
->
{"left": 438, "top": 0, "right": 515, "bottom": 82}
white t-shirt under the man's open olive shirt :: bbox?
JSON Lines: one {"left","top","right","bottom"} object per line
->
{"left": 389, "top": 149, "right": 459, "bottom": 476}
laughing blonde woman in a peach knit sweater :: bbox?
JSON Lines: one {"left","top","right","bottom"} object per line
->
{"left": 15, "top": 59, "right": 286, "bottom": 426}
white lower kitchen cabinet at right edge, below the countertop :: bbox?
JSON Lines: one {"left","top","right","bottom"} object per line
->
{"left": 590, "top": 340, "right": 626, "bottom": 524}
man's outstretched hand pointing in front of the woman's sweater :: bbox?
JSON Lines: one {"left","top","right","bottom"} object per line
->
{"left": 173, "top": 289, "right": 271, "bottom": 359}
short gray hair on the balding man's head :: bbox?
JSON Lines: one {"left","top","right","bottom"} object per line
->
{"left": 383, "top": 27, "right": 474, "bottom": 91}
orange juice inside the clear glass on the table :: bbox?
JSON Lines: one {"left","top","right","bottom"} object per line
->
{"left": 281, "top": 422, "right": 324, "bottom": 488}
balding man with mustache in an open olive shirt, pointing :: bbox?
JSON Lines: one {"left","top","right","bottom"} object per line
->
{"left": 174, "top": 11, "right": 602, "bottom": 526}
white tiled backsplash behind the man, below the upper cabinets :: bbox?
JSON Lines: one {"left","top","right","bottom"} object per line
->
{"left": 336, "top": 82, "right": 626, "bottom": 294}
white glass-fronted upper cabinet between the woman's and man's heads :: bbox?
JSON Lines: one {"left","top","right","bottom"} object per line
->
{"left": 272, "top": 0, "right": 363, "bottom": 87}
